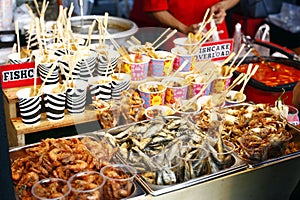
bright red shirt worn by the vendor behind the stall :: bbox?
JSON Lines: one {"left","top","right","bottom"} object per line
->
{"left": 143, "top": 0, "right": 229, "bottom": 39}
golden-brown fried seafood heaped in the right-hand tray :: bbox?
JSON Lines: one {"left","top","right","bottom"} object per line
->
{"left": 193, "top": 104, "right": 292, "bottom": 162}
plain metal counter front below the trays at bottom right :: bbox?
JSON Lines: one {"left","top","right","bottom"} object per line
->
{"left": 148, "top": 157, "right": 300, "bottom": 200}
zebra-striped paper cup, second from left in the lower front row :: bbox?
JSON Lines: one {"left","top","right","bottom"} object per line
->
{"left": 44, "top": 85, "right": 66, "bottom": 121}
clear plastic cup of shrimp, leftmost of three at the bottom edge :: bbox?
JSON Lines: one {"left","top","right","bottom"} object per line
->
{"left": 31, "top": 178, "right": 71, "bottom": 200}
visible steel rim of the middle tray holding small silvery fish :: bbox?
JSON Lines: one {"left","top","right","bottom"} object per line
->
{"left": 100, "top": 116, "right": 248, "bottom": 196}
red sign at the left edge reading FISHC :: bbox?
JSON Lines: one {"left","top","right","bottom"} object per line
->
{"left": 0, "top": 62, "right": 42, "bottom": 88}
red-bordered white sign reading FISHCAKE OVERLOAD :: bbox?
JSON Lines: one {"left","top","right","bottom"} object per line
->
{"left": 197, "top": 39, "right": 233, "bottom": 61}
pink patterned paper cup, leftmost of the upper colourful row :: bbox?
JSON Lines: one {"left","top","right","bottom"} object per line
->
{"left": 122, "top": 55, "right": 150, "bottom": 81}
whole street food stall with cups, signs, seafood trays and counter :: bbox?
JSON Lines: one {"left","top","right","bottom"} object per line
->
{"left": 1, "top": 3, "right": 300, "bottom": 199}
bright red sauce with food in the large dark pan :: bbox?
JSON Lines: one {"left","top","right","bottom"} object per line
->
{"left": 237, "top": 62, "right": 300, "bottom": 86}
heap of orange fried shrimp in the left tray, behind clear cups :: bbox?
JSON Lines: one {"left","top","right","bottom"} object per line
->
{"left": 11, "top": 138, "right": 108, "bottom": 199}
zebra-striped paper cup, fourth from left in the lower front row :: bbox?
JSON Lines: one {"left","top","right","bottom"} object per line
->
{"left": 88, "top": 76, "right": 112, "bottom": 101}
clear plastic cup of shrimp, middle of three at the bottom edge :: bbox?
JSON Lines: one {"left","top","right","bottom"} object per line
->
{"left": 68, "top": 171, "right": 106, "bottom": 200}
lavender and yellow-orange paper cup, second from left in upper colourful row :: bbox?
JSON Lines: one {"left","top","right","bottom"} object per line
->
{"left": 149, "top": 51, "right": 175, "bottom": 78}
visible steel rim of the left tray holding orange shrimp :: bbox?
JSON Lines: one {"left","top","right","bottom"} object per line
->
{"left": 9, "top": 133, "right": 146, "bottom": 200}
